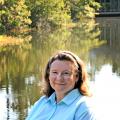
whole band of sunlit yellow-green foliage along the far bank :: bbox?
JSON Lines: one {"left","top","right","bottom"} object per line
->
{"left": 0, "top": 0, "right": 100, "bottom": 33}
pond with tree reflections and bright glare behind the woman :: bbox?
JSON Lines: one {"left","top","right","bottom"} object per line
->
{"left": 0, "top": 17, "right": 120, "bottom": 120}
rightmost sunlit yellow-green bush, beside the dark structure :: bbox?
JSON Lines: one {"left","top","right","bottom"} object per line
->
{"left": 67, "top": 0, "right": 100, "bottom": 20}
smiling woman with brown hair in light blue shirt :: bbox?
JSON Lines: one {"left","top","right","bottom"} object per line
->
{"left": 27, "top": 51, "right": 96, "bottom": 120}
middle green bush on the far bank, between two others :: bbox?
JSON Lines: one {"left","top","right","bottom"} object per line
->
{"left": 27, "top": 0, "right": 70, "bottom": 27}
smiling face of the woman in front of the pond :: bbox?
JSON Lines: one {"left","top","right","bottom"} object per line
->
{"left": 49, "top": 60, "right": 78, "bottom": 95}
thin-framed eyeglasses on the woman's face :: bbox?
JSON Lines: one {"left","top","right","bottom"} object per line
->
{"left": 50, "top": 71, "right": 74, "bottom": 79}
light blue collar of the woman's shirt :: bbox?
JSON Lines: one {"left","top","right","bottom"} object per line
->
{"left": 48, "top": 89, "right": 81, "bottom": 105}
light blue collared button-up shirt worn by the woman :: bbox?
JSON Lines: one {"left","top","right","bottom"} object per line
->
{"left": 26, "top": 89, "right": 96, "bottom": 120}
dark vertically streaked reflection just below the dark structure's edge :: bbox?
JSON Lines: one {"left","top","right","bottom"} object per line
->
{"left": 96, "top": 17, "right": 120, "bottom": 51}
